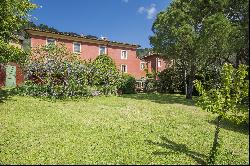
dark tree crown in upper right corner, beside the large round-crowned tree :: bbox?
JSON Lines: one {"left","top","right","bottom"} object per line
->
{"left": 201, "top": 0, "right": 249, "bottom": 67}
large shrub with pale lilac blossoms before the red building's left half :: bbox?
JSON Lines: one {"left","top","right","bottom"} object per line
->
{"left": 20, "top": 45, "right": 89, "bottom": 98}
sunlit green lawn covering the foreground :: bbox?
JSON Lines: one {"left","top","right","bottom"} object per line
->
{"left": 0, "top": 94, "right": 249, "bottom": 164}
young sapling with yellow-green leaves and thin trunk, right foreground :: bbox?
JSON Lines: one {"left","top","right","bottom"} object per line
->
{"left": 195, "top": 64, "right": 249, "bottom": 164}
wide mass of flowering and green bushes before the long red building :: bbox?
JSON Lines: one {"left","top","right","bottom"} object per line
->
{"left": 19, "top": 44, "right": 122, "bottom": 98}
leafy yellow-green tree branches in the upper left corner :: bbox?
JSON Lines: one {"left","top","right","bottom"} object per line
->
{"left": 0, "top": 0, "right": 36, "bottom": 64}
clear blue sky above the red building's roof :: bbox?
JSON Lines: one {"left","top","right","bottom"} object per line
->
{"left": 28, "top": 0, "right": 171, "bottom": 48}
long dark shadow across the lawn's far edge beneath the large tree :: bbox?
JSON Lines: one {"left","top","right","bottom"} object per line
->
{"left": 120, "top": 93, "right": 195, "bottom": 106}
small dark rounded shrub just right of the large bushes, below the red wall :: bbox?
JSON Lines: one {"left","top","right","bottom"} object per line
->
{"left": 119, "top": 74, "right": 136, "bottom": 94}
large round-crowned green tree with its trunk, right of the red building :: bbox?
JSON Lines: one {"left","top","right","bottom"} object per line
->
{"left": 150, "top": 0, "right": 248, "bottom": 99}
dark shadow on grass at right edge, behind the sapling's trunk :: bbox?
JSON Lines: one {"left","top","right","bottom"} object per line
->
{"left": 208, "top": 119, "right": 249, "bottom": 135}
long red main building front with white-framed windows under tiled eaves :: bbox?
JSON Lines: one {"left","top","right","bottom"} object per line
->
{"left": 26, "top": 29, "right": 146, "bottom": 79}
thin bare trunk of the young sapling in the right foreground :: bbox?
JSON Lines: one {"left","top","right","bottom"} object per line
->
{"left": 207, "top": 115, "right": 222, "bottom": 165}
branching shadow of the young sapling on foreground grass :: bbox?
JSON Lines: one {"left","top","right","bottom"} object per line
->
{"left": 146, "top": 137, "right": 207, "bottom": 165}
